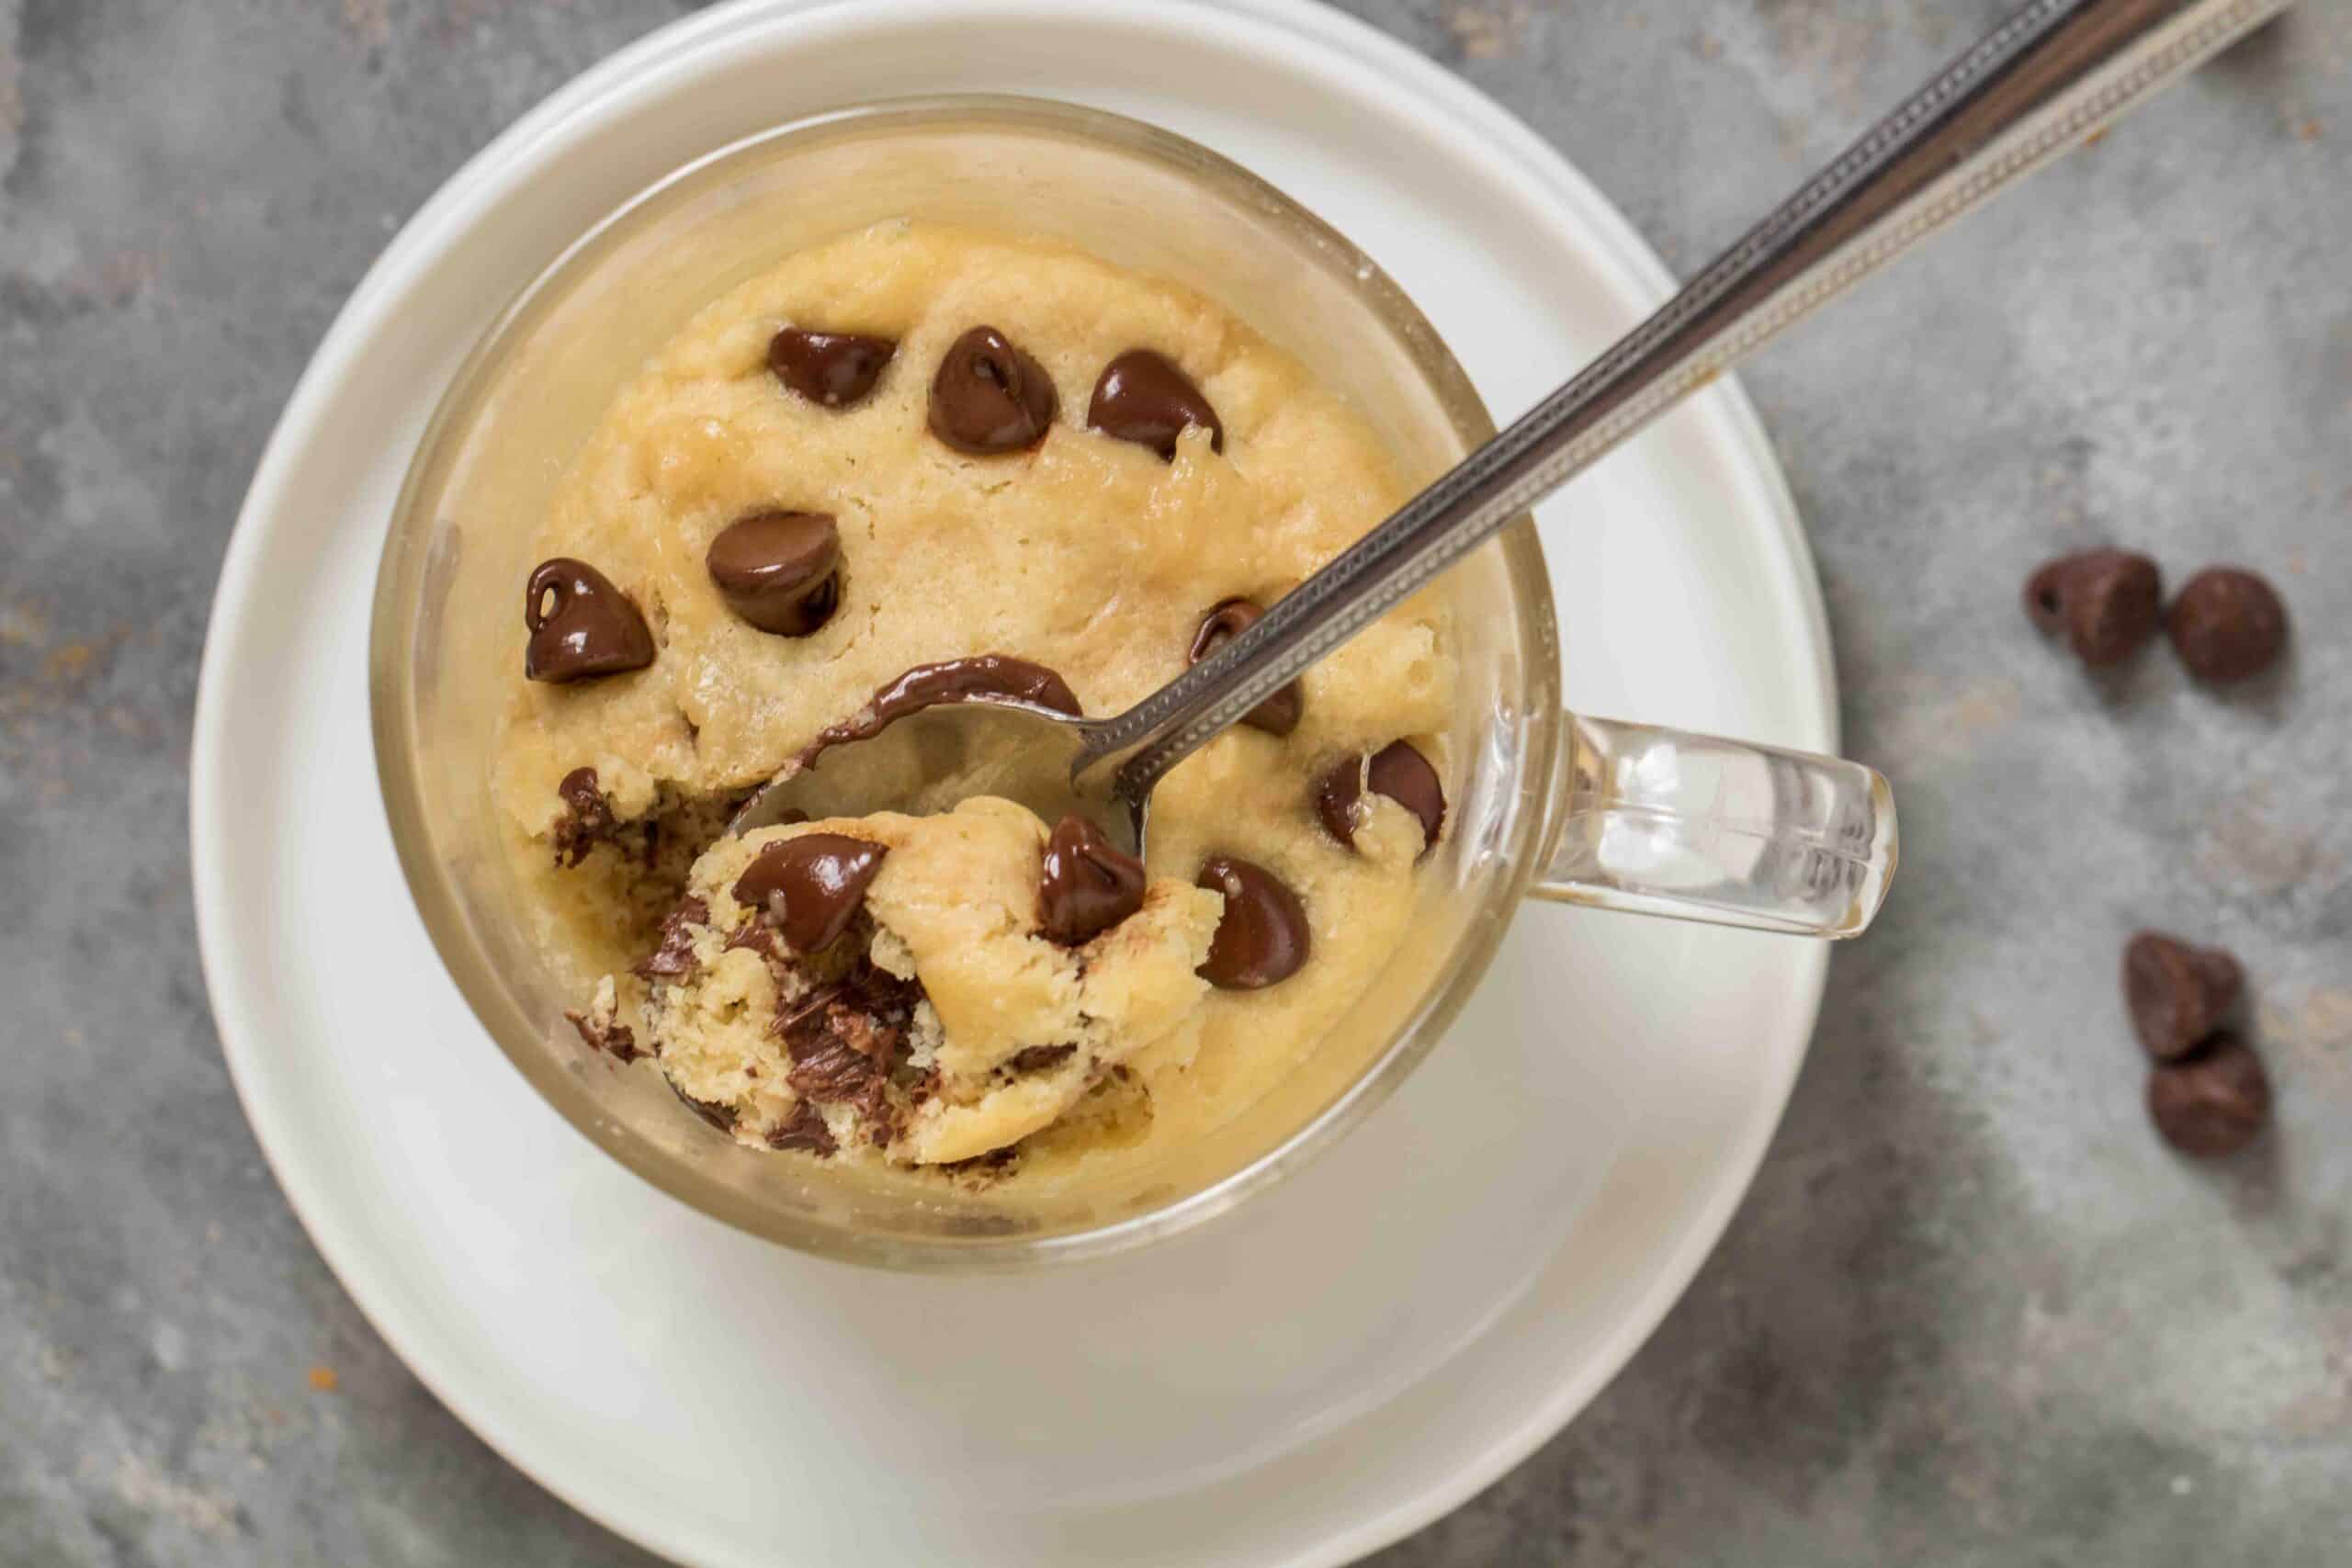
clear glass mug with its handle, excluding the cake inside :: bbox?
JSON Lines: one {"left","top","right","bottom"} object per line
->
{"left": 369, "top": 98, "right": 1895, "bottom": 1269}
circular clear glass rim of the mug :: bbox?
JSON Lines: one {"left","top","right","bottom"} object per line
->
{"left": 369, "top": 94, "right": 1562, "bottom": 1269}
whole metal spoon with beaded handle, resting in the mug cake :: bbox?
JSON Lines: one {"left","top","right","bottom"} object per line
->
{"left": 729, "top": 0, "right": 2286, "bottom": 853}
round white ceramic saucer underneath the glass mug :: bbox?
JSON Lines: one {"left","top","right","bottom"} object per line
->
{"left": 190, "top": 0, "right": 1837, "bottom": 1568}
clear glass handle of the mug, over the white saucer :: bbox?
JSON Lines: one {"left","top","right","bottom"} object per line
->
{"left": 1529, "top": 712, "right": 1895, "bottom": 941}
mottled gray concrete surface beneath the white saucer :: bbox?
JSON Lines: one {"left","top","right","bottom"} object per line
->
{"left": 0, "top": 0, "right": 2352, "bottom": 1568}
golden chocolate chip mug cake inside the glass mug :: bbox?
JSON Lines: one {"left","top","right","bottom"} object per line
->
{"left": 492, "top": 221, "right": 1453, "bottom": 1180}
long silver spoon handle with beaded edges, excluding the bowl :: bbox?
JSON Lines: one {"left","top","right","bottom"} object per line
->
{"left": 1091, "top": 0, "right": 2286, "bottom": 802}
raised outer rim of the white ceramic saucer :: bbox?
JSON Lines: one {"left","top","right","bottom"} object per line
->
{"left": 190, "top": 0, "right": 1837, "bottom": 1563}
